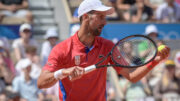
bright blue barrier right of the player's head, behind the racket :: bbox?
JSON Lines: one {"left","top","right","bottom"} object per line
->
{"left": 71, "top": 23, "right": 180, "bottom": 40}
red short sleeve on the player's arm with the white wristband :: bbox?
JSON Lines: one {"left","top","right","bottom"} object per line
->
{"left": 43, "top": 47, "right": 63, "bottom": 72}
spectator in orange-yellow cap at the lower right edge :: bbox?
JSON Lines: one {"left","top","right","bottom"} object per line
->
{"left": 154, "top": 60, "right": 180, "bottom": 101}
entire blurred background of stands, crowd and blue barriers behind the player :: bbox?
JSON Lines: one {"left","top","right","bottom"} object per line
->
{"left": 0, "top": 0, "right": 180, "bottom": 101}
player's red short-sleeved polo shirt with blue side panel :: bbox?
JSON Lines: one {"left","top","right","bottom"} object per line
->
{"left": 44, "top": 33, "right": 121, "bottom": 101}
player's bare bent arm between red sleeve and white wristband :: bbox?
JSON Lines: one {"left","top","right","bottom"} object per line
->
{"left": 37, "top": 71, "right": 57, "bottom": 89}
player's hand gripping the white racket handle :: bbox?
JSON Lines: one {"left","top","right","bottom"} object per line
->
{"left": 62, "top": 66, "right": 85, "bottom": 81}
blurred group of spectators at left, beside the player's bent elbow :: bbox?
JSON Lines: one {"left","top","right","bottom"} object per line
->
{"left": 0, "top": 23, "right": 59, "bottom": 101}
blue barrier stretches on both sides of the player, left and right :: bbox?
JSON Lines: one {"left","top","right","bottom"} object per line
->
{"left": 0, "top": 23, "right": 180, "bottom": 40}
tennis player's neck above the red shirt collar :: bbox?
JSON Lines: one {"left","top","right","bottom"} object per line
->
{"left": 78, "top": 28, "right": 95, "bottom": 48}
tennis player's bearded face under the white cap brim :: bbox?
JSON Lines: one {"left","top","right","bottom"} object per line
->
{"left": 89, "top": 11, "right": 106, "bottom": 36}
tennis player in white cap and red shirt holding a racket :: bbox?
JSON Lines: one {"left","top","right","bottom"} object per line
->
{"left": 38, "top": 0, "right": 169, "bottom": 101}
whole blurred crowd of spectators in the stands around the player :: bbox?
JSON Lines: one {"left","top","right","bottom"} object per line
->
{"left": 0, "top": 0, "right": 180, "bottom": 101}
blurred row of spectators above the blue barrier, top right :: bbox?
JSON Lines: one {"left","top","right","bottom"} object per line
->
{"left": 72, "top": 0, "right": 180, "bottom": 23}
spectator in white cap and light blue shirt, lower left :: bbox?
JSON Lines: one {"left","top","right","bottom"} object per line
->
{"left": 13, "top": 59, "right": 44, "bottom": 101}
